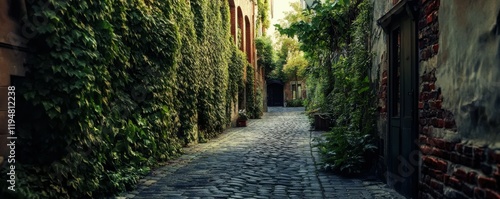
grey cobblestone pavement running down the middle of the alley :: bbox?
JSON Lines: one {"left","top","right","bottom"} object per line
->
{"left": 117, "top": 107, "right": 402, "bottom": 199}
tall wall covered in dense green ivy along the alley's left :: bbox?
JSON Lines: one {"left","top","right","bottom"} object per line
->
{"left": 0, "top": 0, "right": 253, "bottom": 198}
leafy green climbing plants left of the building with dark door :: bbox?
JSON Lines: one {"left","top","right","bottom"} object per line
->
{"left": 278, "top": 0, "right": 376, "bottom": 174}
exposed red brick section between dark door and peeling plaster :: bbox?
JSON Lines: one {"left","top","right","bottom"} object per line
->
{"left": 418, "top": 0, "right": 500, "bottom": 199}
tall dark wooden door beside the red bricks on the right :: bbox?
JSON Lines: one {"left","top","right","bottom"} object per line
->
{"left": 387, "top": 16, "right": 418, "bottom": 198}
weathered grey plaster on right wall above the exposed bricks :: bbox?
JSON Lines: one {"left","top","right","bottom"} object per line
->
{"left": 436, "top": 0, "right": 500, "bottom": 148}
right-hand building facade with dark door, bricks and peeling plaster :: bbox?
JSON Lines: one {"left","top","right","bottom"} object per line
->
{"left": 371, "top": 0, "right": 500, "bottom": 198}
